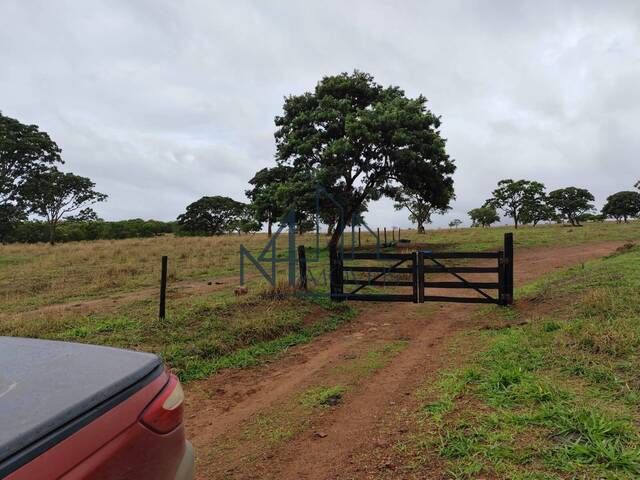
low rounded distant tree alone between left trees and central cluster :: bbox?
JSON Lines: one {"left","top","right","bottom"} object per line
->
{"left": 178, "top": 196, "right": 246, "bottom": 235}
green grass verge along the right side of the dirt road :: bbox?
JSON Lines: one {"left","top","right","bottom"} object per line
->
{"left": 398, "top": 245, "right": 640, "bottom": 479}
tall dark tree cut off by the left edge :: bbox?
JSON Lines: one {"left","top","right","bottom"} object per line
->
{"left": 0, "top": 112, "right": 62, "bottom": 242}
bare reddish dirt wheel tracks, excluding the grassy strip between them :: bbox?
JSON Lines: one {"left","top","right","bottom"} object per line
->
{"left": 186, "top": 242, "right": 624, "bottom": 479}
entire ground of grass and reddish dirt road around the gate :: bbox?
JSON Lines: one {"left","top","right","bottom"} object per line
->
{"left": 0, "top": 222, "right": 640, "bottom": 479}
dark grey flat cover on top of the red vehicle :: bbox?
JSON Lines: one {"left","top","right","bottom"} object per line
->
{"left": 0, "top": 337, "right": 162, "bottom": 465}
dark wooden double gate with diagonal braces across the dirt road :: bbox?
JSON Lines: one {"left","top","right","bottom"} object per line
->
{"left": 330, "top": 233, "right": 513, "bottom": 305}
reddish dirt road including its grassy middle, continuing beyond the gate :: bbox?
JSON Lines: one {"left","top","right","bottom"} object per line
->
{"left": 187, "top": 242, "right": 623, "bottom": 479}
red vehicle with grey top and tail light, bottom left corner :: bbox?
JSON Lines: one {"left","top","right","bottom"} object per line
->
{"left": 0, "top": 337, "right": 194, "bottom": 480}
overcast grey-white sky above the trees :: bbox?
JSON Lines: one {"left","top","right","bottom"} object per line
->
{"left": 0, "top": 0, "right": 640, "bottom": 227}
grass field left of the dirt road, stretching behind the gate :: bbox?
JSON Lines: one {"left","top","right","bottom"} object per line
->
{"left": 0, "top": 222, "right": 640, "bottom": 380}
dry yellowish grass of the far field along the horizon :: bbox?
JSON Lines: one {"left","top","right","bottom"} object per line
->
{"left": 0, "top": 222, "right": 640, "bottom": 312}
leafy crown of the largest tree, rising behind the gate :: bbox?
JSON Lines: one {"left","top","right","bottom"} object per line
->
{"left": 275, "top": 71, "right": 455, "bottom": 245}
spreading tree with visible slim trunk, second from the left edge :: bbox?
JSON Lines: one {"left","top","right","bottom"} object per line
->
{"left": 22, "top": 168, "right": 107, "bottom": 245}
